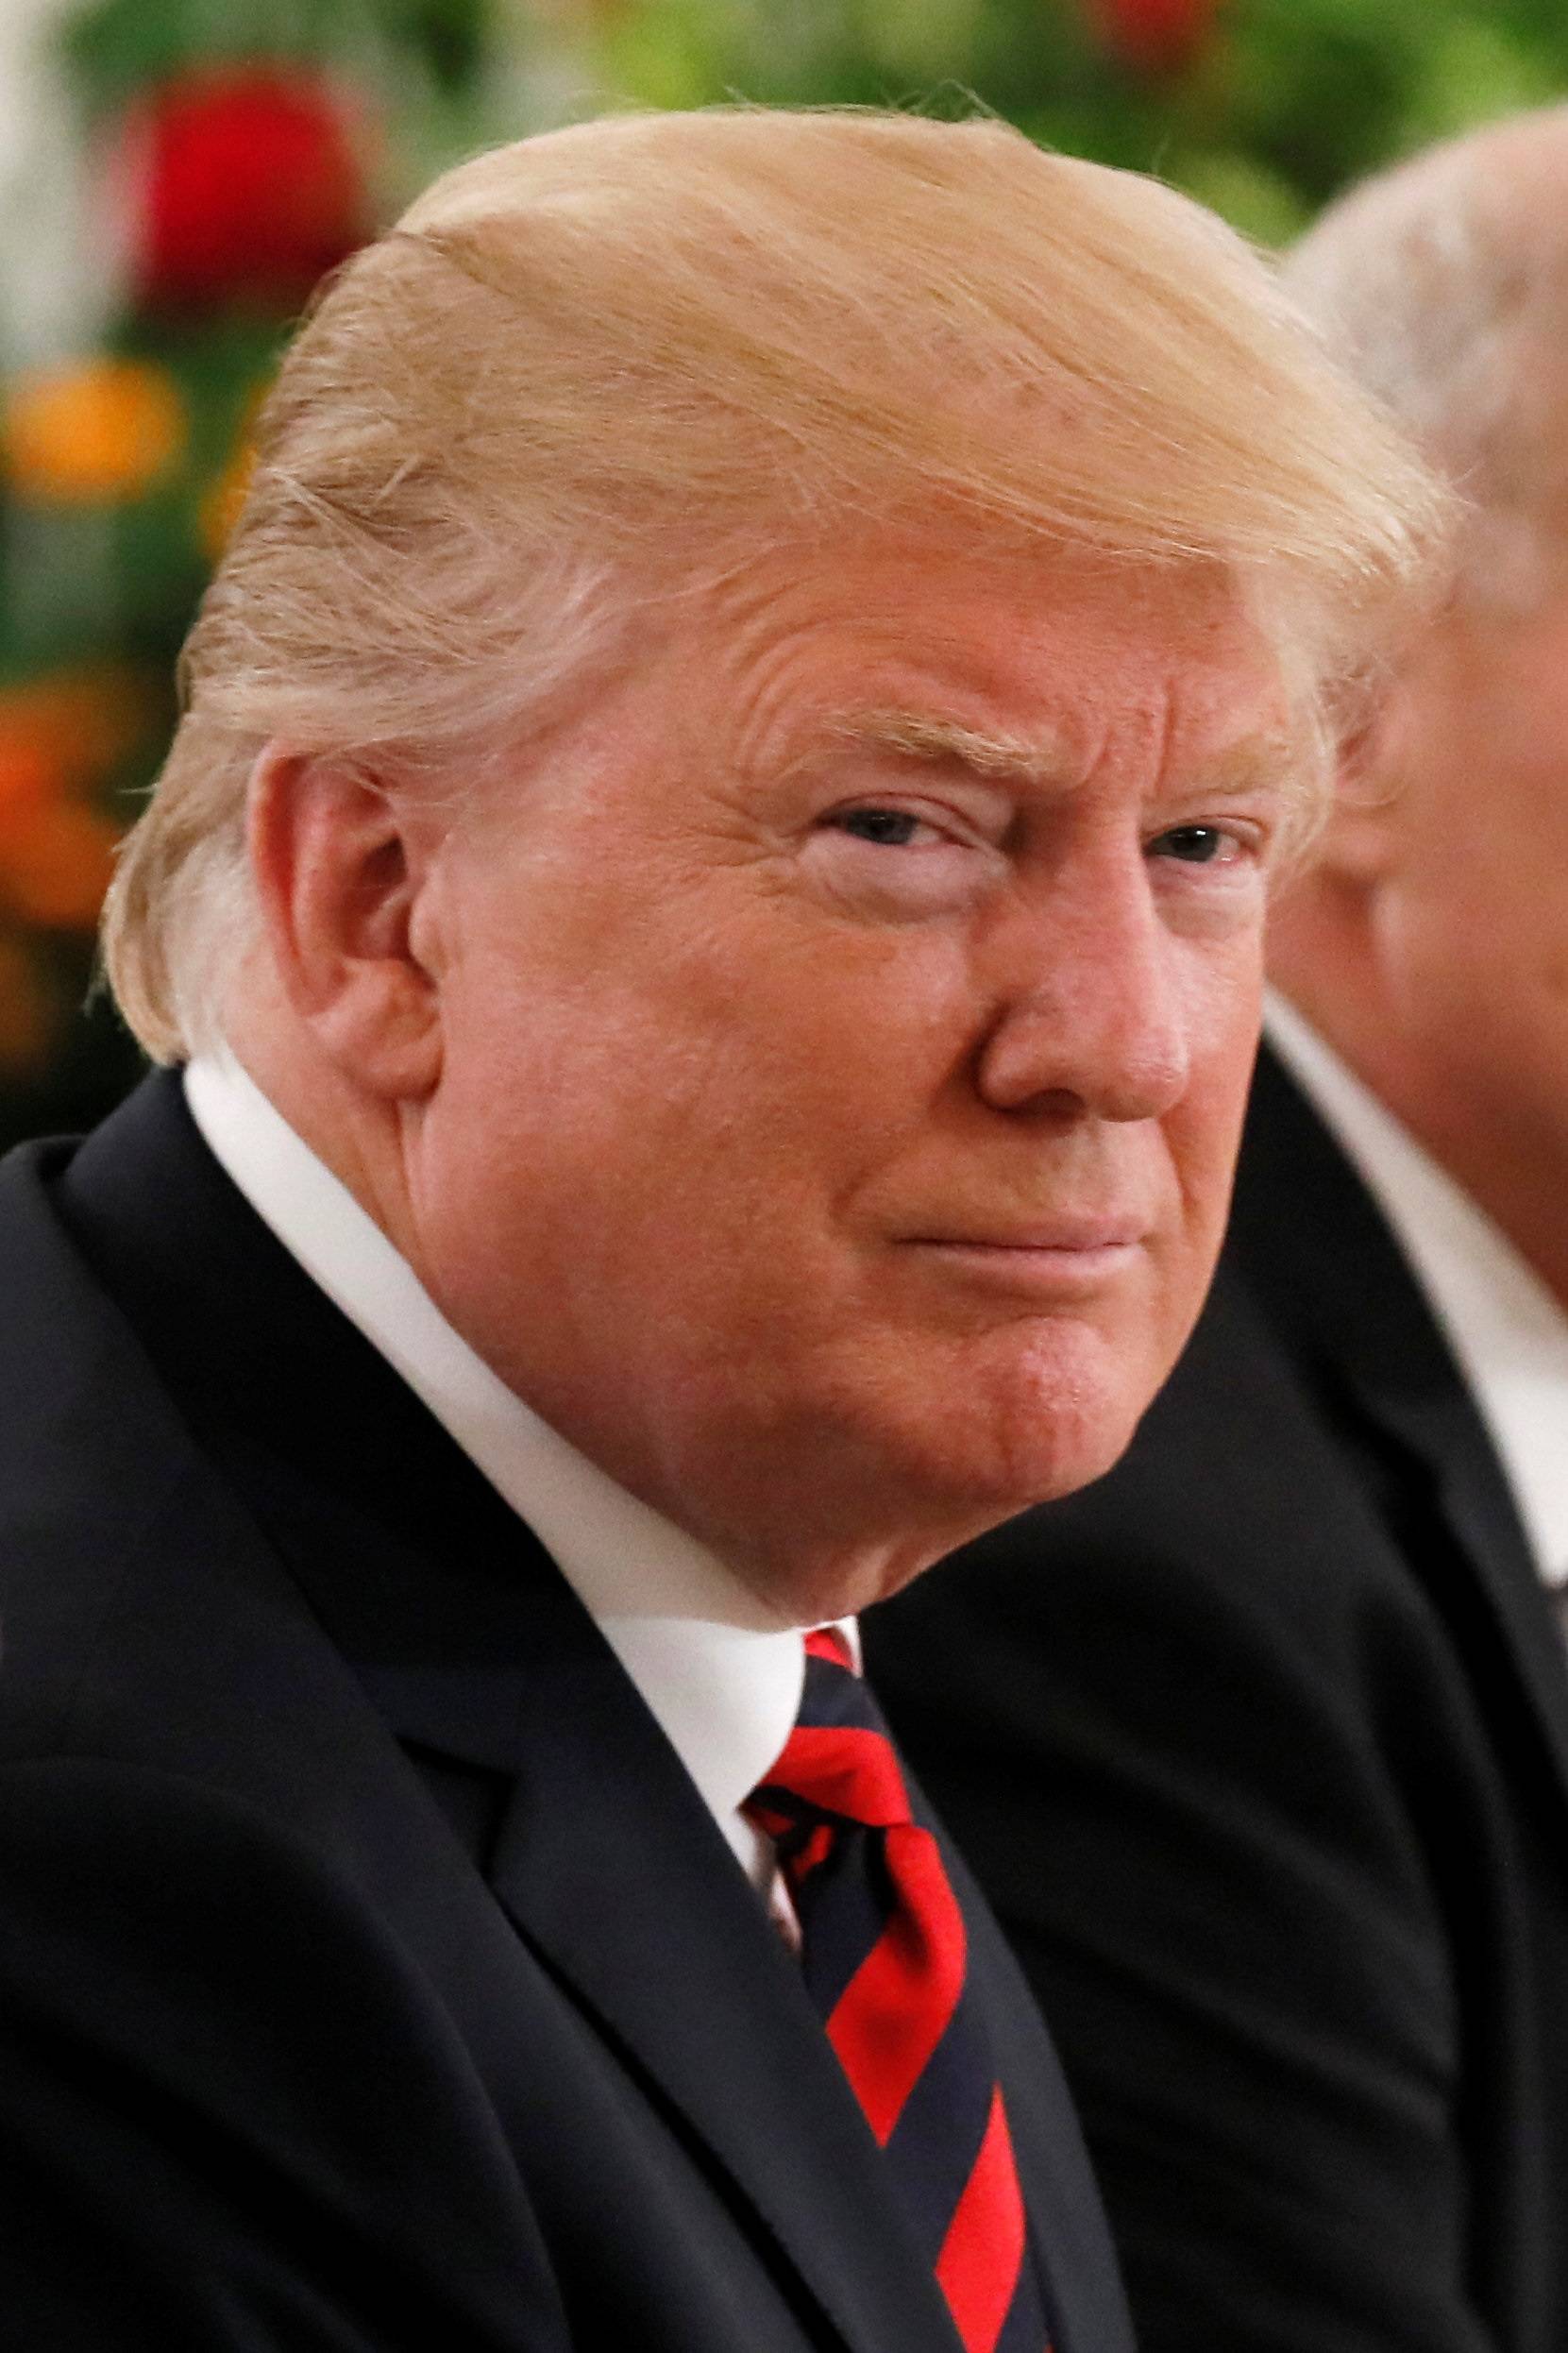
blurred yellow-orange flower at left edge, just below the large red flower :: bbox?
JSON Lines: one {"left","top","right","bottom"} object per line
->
{"left": 5, "top": 360, "right": 188, "bottom": 506}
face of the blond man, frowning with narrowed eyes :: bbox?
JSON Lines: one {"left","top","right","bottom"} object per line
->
{"left": 409, "top": 534, "right": 1284, "bottom": 1615}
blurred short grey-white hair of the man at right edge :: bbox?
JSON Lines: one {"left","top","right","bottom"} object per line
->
{"left": 1281, "top": 106, "right": 1568, "bottom": 612}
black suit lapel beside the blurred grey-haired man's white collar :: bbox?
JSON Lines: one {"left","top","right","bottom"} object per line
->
{"left": 1227, "top": 1052, "right": 1568, "bottom": 1804}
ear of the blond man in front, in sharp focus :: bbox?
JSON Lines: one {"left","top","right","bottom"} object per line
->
{"left": 246, "top": 743, "right": 442, "bottom": 1099}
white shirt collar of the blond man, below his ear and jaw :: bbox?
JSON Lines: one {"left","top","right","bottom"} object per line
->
{"left": 186, "top": 1054, "right": 853, "bottom": 1891}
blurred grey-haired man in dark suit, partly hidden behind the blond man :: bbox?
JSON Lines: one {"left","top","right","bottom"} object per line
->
{"left": 872, "top": 110, "right": 1568, "bottom": 2353}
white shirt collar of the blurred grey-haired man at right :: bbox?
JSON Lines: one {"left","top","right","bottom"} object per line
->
{"left": 1265, "top": 995, "right": 1568, "bottom": 1593}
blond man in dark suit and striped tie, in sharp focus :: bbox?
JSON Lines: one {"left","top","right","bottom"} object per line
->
{"left": 0, "top": 110, "right": 1443, "bottom": 2353}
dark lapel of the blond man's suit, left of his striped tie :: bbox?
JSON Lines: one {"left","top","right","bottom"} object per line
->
{"left": 59, "top": 1080, "right": 957, "bottom": 2353}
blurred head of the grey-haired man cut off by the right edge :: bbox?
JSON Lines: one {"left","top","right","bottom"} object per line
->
{"left": 1270, "top": 106, "right": 1568, "bottom": 1306}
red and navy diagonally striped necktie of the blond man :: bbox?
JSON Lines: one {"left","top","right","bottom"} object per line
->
{"left": 748, "top": 1631, "right": 1049, "bottom": 2353}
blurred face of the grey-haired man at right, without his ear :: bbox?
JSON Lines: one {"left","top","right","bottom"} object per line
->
{"left": 1375, "top": 590, "right": 1568, "bottom": 1259}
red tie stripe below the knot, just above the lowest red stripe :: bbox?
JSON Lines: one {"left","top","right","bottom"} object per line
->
{"left": 828, "top": 1821, "right": 966, "bottom": 2148}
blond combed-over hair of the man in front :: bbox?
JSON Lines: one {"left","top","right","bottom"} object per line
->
{"left": 106, "top": 109, "right": 1442, "bottom": 1058}
